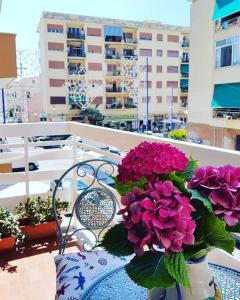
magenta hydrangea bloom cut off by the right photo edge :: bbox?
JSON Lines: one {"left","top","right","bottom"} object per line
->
{"left": 188, "top": 165, "right": 240, "bottom": 226}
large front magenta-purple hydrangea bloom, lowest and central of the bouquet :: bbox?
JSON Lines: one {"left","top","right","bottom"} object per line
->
{"left": 118, "top": 181, "right": 196, "bottom": 256}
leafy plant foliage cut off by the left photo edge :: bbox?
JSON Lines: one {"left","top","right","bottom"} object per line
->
{"left": 0, "top": 207, "right": 24, "bottom": 244}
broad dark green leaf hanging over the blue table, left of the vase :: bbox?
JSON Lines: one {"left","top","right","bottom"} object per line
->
{"left": 125, "top": 251, "right": 175, "bottom": 289}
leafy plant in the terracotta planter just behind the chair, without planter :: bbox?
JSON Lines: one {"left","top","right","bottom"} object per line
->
{"left": 16, "top": 196, "right": 69, "bottom": 225}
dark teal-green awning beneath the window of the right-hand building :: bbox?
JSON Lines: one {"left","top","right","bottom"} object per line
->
{"left": 211, "top": 82, "right": 240, "bottom": 108}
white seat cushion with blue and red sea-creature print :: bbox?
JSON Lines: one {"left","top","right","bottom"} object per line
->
{"left": 55, "top": 251, "right": 130, "bottom": 300}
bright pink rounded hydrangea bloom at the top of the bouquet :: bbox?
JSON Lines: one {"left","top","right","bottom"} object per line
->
{"left": 117, "top": 142, "right": 189, "bottom": 184}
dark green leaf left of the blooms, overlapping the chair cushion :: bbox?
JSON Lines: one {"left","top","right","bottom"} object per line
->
{"left": 99, "top": 224, "right": 134, "bottom": 256}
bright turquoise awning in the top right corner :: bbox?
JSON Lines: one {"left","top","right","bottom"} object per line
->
{"left": 212, "top": 0, "right": 240, "bottom": 21}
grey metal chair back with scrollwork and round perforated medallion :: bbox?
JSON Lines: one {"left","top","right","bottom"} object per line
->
{"left": 52, "top": 159, "right": 119, "bottom": 255}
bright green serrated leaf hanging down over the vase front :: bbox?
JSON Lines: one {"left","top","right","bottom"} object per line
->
{"left": 164, "top": 252, "right": 190, "bottom": 288}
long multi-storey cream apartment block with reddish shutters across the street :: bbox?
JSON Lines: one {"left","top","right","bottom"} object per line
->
{"left": 38, "top": 12, "right": 189, "bottom": 127}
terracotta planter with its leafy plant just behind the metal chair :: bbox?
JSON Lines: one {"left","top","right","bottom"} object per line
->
{"left": 16, "top": 197, "right": 69, "bottom": 240}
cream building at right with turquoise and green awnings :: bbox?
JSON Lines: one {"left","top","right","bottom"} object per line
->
{"left": 188, "top": 0, "right": 240, "bottom": 150}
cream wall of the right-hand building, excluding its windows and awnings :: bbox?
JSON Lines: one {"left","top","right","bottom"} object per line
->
{"left": 188, "top": 0, "right": 240, "bottom": 149}
